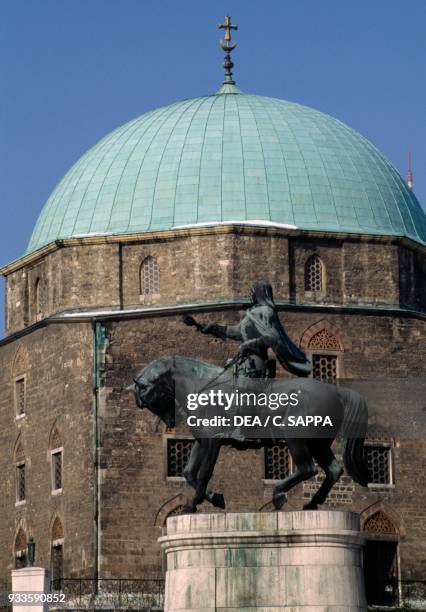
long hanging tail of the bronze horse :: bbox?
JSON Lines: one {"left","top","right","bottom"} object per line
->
{"left": 337, "top": 387, "right": 370, "bottom": 487}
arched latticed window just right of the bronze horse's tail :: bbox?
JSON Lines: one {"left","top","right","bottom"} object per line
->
{"left": 365, "top": 426, "right": 394, "bottom": 487}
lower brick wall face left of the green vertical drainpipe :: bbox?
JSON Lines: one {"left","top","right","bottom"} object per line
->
{"left": 0, "top": 324, "right": 94, "bottom": 579}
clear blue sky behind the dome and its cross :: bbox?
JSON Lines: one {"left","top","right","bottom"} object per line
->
{"left": 0, "top": 0, "right": 426, "bottom": 335}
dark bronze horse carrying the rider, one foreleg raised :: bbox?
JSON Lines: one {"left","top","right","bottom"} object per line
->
{"left": 127, "top": 356, "right": 369, "bottom": 513}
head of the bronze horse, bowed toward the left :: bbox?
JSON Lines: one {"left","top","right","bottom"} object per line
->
{"left": 126, "top": 359, "right": 175, "bottom": 427}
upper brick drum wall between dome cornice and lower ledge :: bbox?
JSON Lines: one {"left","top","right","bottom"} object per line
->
{"left": 6, "top": 227, "right": 426, "bottom": 334}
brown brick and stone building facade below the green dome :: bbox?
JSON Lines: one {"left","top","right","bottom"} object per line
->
{"left": 0, "top": 76, "right": 426, "bottom": 608}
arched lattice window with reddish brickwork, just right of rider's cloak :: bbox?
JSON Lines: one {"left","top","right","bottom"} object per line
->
{"left": 308, "top": 328, "right": 342, "bottom": 383}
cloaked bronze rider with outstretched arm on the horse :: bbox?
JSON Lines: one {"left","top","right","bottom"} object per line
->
{"left": 200, "top": 281, "right": 312, "bottom": 378}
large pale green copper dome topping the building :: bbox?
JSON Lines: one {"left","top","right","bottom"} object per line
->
{"left": 27, "top": 85, "right": 426, "bottom": 253}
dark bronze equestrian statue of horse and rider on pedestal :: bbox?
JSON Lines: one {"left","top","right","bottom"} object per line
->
{"left": 128, "top": 281, "right": 369, "bottom": 513}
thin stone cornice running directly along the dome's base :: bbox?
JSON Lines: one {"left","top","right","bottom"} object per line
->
{"left": 0, "top": 223, "right": 426, "bottom": 276}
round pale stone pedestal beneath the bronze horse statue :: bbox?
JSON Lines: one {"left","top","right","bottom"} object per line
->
{"left": 160, "top": 510, "right": 367, "bottom": 612}
